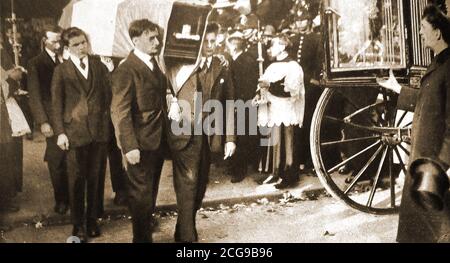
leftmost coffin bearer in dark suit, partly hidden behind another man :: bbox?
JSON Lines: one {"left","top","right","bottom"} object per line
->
{"left": 27, "top": 28, "right": 69, "bottom": 214}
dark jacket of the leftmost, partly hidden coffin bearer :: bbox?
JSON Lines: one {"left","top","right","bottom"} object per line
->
{"left": 27, "top": 51, "right": 56, "bottom": 125}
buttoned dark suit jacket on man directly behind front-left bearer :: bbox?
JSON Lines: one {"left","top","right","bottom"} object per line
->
{"left": 51, "top": 56, "right": 111, "bottom": 147}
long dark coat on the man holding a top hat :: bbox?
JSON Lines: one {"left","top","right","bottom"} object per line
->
{"left": 397, "top": 48, "right": 450, "bottom": 242}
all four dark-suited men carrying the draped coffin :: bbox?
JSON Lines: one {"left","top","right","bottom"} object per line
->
{"left": 28, "top": 19, "right": 236, "bottom": 242}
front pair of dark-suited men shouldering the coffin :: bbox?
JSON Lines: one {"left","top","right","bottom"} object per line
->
{"left": 111, "top": 19, "right": 236, "bottom": 242}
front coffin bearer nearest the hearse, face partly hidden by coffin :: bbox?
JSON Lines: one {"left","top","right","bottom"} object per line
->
{"left": 169, "top": 24, "right": 236, "bottom": 242}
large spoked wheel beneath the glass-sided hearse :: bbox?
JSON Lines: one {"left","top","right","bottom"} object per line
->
{"left": 310, "top": 87, "right": 412, "bottom": 214}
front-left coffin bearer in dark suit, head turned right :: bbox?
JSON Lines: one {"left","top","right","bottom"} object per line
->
{"left": 111, "top": 19, "right": 167, "bottom": 243}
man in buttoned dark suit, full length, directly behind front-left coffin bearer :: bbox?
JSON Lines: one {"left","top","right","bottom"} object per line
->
{"left": 51, "top": 27, "right": 111, "bottom": 243}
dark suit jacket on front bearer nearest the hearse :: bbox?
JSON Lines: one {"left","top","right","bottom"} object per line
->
{"left": 169, "top": 57, "right": 236, "bottom": 152}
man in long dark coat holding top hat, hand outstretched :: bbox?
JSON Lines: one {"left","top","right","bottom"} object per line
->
{"left": 378, "top": 5, "right": 450, "bottom": 243}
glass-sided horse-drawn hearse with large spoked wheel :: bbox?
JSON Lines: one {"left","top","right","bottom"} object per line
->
{"left": 310, "top": 0, "right": 431, "bottom": 214}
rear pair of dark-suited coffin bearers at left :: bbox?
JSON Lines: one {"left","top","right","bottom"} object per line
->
{"left": 27, "top": 28, "right": 126, "bottom": 243}
